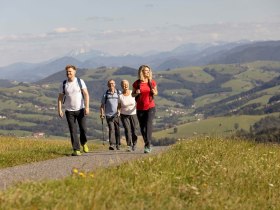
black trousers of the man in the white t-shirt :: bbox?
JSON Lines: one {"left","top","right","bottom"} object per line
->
{"left": 65, "top": 109, "right": 87, "bottom": 150}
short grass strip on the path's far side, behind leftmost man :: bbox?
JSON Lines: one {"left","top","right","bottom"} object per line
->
{"left": 0, "top": 137, "right": 100, "bottom": 168}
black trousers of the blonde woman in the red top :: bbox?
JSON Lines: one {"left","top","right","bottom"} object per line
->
{"left": 137, "top": 107, "right": 156, "bottom": 148}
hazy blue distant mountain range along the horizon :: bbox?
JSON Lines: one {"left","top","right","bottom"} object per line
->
{"left": 0, "top": 41, "right": 280, "bottom": 82}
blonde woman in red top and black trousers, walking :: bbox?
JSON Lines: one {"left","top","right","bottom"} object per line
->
{"left": 132, "top": 65, "right": 158, "bottom": 153}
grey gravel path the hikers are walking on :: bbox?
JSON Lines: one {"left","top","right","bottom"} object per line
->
{"left": 0, "top": 147, "right": 167, "bottom": 190}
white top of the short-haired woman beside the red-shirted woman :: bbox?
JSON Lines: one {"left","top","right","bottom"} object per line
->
{"left": 119, "top": 91, "right": 136, "bottom": 115}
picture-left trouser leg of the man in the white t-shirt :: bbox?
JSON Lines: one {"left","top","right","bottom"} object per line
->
{"left": 65, "top": 111, "right": 80, "bottom": 150}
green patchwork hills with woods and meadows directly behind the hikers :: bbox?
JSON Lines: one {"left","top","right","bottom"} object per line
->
{"left": 0, "top": 61, "right": 280, "bottom": 138}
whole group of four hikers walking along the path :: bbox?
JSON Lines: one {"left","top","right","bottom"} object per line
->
{"left": 57, "top": 65, "right": 158, "bottom": 156}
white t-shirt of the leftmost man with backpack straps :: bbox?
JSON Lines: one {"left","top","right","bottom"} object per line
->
{"left": 60, "top": 77, "right": 87, "bottom": 111}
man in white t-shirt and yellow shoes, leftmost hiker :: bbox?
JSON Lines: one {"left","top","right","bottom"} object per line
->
{"left": 57, "top": 65, "right": 89, "bottom": 156}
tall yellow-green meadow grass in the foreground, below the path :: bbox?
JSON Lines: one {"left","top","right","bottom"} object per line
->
{"left": 0, "top": 137, "right": 280, "bottom": 209}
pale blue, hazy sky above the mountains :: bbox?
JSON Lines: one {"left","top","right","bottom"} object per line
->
{"left": 0, "top": 0, "right": 280, "bottom": 66}
